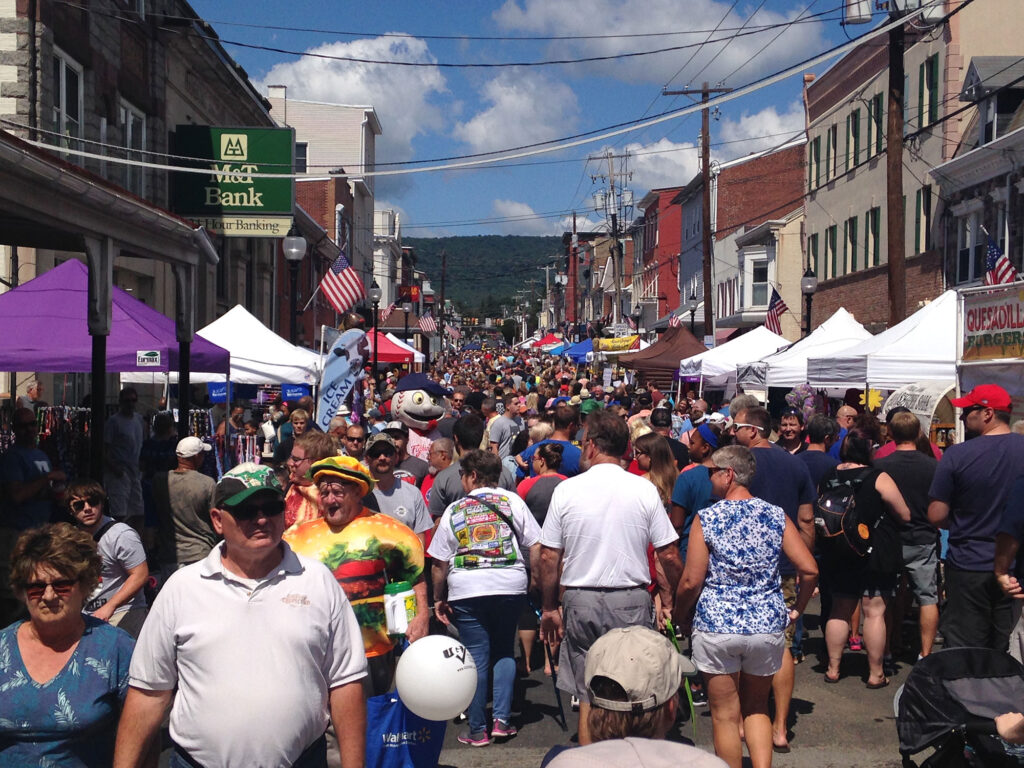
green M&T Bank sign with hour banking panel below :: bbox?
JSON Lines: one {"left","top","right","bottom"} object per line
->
{"left": 171, "top": 125, "right": 295, "bottom": 238}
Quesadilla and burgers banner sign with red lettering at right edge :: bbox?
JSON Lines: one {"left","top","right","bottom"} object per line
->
{"left": 962, "top": 287, "right": 1024, "bottom": 361}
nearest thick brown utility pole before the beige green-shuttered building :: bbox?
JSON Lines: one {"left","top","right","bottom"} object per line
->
{"left": 886, "top": 25, "right": 906, "bottom": 328}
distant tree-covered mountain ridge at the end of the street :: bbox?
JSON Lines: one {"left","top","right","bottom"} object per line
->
{"left": 401, "top": 234, "right": 563, "bottom": 315}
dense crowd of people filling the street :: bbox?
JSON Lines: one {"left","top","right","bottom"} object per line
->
{"left": 0, "top": 350, "right": 1024, "bottom": 768}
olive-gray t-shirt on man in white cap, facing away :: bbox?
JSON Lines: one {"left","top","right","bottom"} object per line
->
{"left": 153, "top": 470, "right": 220, "bottom": 565}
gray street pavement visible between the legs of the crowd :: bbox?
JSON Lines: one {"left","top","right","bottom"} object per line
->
{"left": 439, "top": 600, "right": 912, "bottom": 768}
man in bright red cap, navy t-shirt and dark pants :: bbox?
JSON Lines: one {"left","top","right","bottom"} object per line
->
{"left": 928, "top": 384, "right": 1024, "bottom": 651}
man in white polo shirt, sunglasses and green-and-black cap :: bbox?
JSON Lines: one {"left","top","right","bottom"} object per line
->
{"left": 114, "top": 463, "right": 367, "bottom": 768}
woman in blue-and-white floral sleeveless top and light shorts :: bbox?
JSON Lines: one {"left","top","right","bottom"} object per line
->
{"left": 676, "top": 445, "right": 818, "bottom": 768}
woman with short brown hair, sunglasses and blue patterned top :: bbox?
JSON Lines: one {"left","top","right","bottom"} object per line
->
{"left": 0, "top": 522, "right": 135, "bottom": 768}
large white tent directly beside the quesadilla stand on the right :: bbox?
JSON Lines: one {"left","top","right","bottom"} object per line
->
{"left": 807, "top": 291, "right": 956, "bottom": 389}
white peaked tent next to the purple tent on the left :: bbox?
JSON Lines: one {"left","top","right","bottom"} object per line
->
{"left": 121, "top": 304, "right": 321, "bottom": 384}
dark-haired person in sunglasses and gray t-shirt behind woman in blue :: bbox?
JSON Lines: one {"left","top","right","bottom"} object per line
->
{"left": 68, "top": 480, "right": 150, "bottom": 637}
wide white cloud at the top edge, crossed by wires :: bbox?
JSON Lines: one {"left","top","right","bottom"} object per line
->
{"left": 494, "top": 0, "right": 824, "bottom": 87}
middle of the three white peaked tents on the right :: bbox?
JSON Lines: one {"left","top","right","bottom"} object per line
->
{"left": 736, "top": 307, "right": 871, "bottom": 389}
